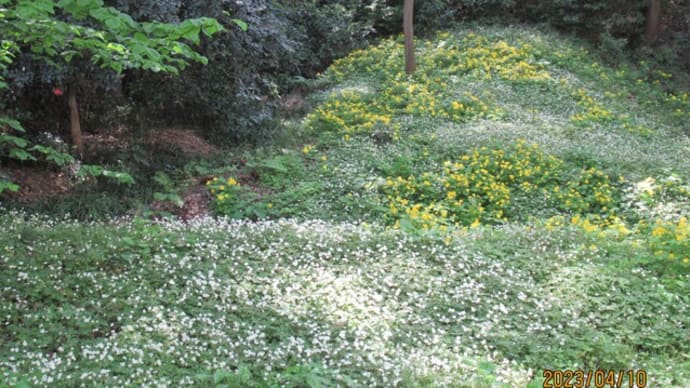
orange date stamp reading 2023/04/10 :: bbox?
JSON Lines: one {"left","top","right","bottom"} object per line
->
{"left": 543, "top": 369, "right": 647, "bottom": 388}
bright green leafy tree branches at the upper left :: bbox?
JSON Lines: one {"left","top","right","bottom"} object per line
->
{"left": 0, "top": 0, "right": 241, "bottom": 192}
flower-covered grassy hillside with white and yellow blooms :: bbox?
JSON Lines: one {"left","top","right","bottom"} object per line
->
{"left": 0, "top": 28, "right": 690, "bottom": 387}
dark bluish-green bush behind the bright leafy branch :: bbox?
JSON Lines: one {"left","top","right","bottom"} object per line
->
{"left": 118, "top": 0, "right": 298, "bottom": 143}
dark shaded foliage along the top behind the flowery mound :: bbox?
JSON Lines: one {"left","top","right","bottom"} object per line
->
{"left": 0, "top": 0, "right": 690, "bottom": 144}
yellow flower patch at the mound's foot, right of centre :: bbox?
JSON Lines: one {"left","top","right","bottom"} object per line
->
{"left": 383, "top": 140, "right": 614, "bottom": 229}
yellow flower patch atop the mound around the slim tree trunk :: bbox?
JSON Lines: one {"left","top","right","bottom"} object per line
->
{"left": 306, "top": 33, "right": 551, "bottom": 139}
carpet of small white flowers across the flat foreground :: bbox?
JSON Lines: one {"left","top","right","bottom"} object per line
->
{"left": 0, "top": 217, "right": 690, "bottom": 386}
